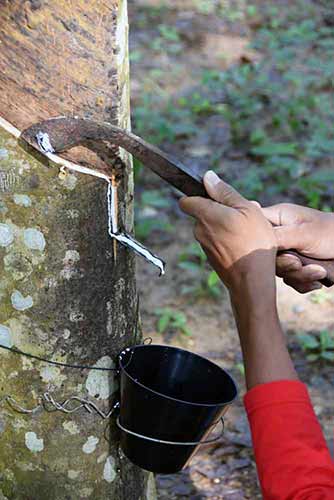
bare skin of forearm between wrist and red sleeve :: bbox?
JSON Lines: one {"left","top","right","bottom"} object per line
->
{"left": 231, "top": 273, "right": 298, "bottom": 389}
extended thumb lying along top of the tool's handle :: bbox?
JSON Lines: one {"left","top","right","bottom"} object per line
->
{"left": 204, "top": 170, "right": 249, "bottom": 208}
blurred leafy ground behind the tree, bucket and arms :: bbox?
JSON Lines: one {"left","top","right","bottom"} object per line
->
{"left": 129, "top": 0, "right": 334, "bottom": 500}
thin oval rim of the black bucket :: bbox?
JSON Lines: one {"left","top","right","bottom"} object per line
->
{"left": 118, "top": 344, "right": 239, "bottom": 408}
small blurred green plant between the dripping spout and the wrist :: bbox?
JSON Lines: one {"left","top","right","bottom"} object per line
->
{"left": 178, "top": 243, "right": 222, "bottom": 298}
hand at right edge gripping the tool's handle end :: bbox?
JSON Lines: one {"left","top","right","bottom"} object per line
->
{"left": 262, "top": 203, "right": 334, "bottom": 293}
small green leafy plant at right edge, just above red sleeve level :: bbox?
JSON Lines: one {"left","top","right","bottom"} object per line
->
{"left": 298, "top": 330, "right": 334, "bottom": 361}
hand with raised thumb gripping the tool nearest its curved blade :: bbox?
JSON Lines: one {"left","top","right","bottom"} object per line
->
{"left": 180, "top": 171, "right": 276, "bottom": 300}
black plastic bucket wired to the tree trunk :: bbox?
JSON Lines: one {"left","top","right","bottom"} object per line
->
{"left": 117, "top": 345, "right": 237, "bottom": 474}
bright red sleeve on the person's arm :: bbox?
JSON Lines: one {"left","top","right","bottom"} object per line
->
{"left": 244, "top": 380, "right": 334, "bottom": 500}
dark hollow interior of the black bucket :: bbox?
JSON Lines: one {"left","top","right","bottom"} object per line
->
{"left": 120, "top": 345, "right": 237, "bottom": 405}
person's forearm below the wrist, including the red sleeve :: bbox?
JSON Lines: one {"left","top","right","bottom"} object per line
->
{"left": 231, "top": 274, "right": 334, "bottom": 500}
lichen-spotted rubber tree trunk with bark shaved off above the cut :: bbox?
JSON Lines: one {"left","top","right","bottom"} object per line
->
{"left": 0, "top": 0, "right": 154, "bottom": 500}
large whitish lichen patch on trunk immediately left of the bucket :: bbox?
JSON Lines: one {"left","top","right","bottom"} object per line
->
{"left": 86, "top": 356, "right": 118, "bottom": 399}
